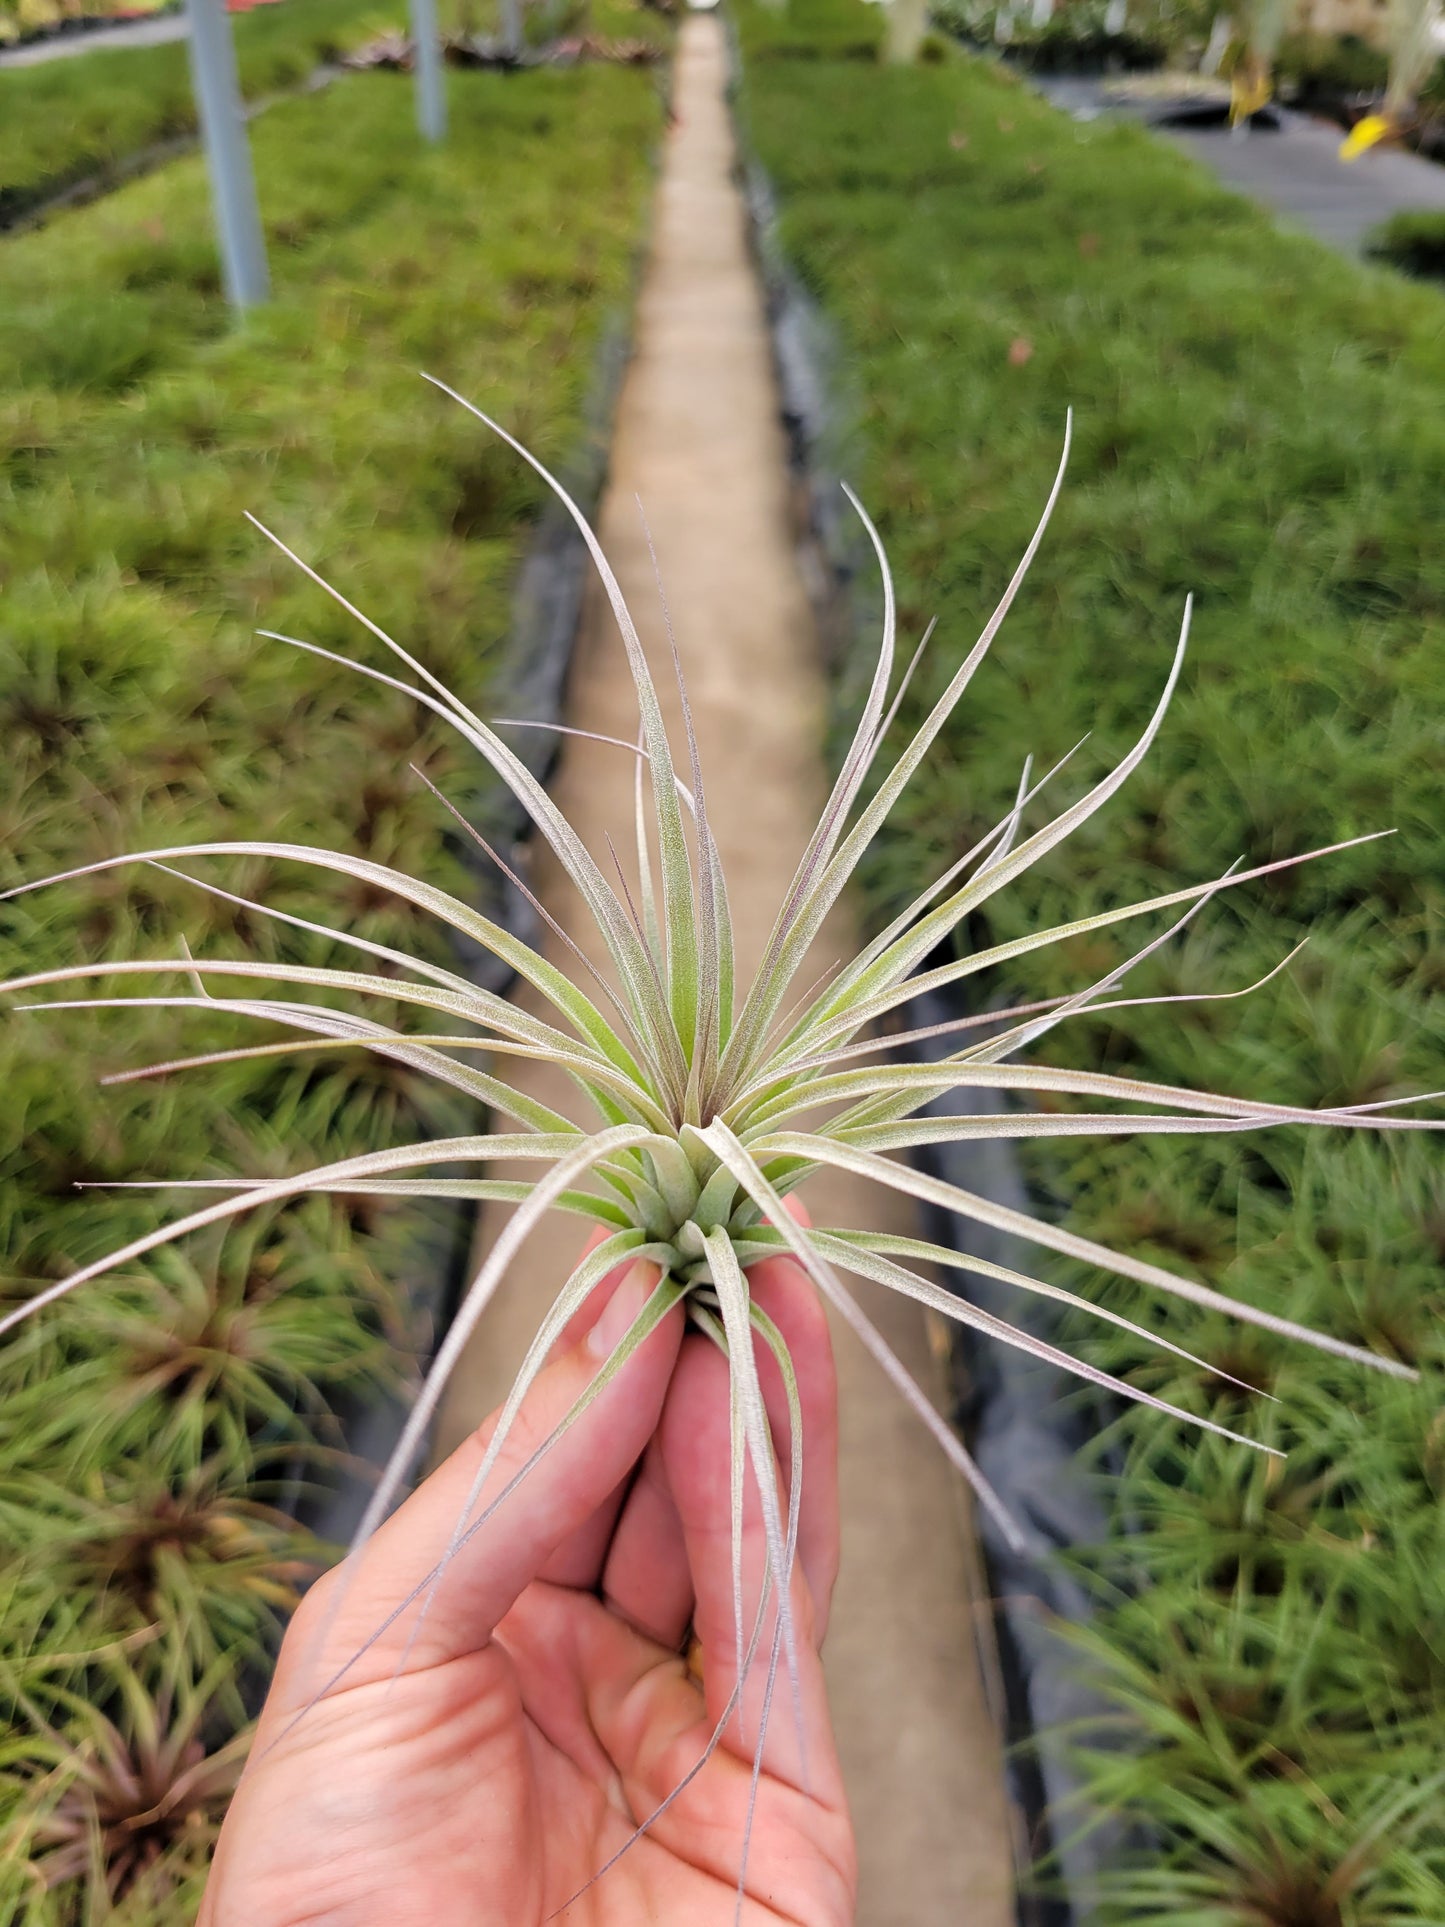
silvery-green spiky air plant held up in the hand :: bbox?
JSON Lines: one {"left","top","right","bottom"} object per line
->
{"left": 0, "top": 383, "right": 1439, "bottom": 1896}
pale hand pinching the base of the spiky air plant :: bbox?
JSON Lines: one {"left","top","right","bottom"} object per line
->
{"left": 200, "top": 1210, "right": 855, "bottom": 1927}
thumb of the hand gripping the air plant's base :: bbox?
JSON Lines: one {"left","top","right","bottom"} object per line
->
{"left": 272, "top": 1264, "right": 682, "bottom": 1700}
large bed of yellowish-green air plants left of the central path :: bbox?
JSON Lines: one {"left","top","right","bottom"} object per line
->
{"left": 0, "top": 52, "right": 661, "bottom": 1927}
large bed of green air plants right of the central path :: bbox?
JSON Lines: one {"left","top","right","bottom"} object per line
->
{"left": 740, "top": 0, "right": 1445, "bottom": 1927}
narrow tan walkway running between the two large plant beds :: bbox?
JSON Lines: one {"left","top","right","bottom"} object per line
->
{"left": 437, "top": 15, "right": 1012, "bottom": 1927}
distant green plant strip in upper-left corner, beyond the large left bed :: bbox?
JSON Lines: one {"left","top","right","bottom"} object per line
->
{"left": 0, "top": 0, "right": 405, "bottom": 224}
